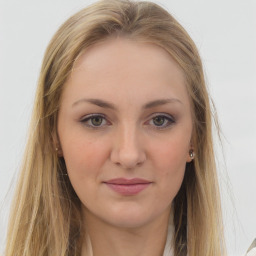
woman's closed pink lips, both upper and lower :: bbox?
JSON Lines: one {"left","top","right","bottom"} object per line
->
{"left": 103, "top": 178, "right": 152, "bottom": 196}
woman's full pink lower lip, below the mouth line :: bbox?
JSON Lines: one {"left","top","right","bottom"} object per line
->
{"left": 105, "top": 183, "right": 151, "bottom": 196}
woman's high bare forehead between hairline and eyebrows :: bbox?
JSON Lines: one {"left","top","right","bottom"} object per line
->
{"left": 64, "top": 38, "right": 188, "bottom": 108}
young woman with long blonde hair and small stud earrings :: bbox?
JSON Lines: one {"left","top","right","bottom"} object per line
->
{"left": 6, "top": 0, "right": 225, "bottom": 256}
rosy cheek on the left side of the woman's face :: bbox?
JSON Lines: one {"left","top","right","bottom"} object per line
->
{"left": 62, "top": 133, "right": 108, "bottom": 201}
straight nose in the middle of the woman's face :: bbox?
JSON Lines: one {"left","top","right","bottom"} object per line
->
{"left": 110, "top": 124, "right": 146, "bottom": 169}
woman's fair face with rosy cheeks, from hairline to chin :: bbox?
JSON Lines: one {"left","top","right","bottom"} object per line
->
{"left": 58, "top": 38, "right": 192, "bottom": 228}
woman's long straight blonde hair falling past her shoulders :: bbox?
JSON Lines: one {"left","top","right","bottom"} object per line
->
{"left": 5, "top": 0, "right": 225, "bottom": 256}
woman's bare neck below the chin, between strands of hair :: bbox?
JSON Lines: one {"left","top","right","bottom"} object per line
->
{"left": 82, "top": 209, "right": 170, "bottom": 256}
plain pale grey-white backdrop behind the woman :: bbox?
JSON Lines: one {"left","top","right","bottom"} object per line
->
{"left": 0, "top": 0, "right": 256, "bottom": 256}
